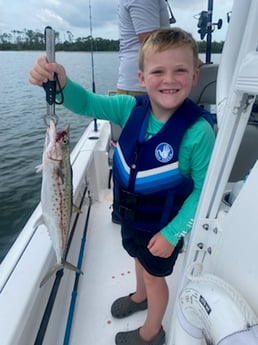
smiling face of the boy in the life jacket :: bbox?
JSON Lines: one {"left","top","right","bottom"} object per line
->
{"left": 138, "top": 46, "right": 199, "bottom": 122}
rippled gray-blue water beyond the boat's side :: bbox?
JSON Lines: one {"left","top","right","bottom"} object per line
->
{"left": 0, "top": 52, "right": 118, "bottom": 262}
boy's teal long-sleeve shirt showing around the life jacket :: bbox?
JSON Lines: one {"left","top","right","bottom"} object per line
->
{"left": 57, "top": 79, "right": 215, "bottom": 246}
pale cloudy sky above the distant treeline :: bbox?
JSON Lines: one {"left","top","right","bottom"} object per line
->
{"left": 0, "top": 0, "right": 233, "bottom": 41}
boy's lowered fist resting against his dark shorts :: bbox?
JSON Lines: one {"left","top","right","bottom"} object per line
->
{"left": 147, "top": 232, "right": 175, "bottom": 258}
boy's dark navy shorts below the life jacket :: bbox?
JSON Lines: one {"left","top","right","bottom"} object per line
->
{"left": 121, "top": 224, "right": 184, "bottom": 277}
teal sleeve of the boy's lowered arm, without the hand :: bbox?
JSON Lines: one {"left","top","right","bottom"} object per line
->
{"left": 161, "top": 119, "right": 215, "bottom": 246}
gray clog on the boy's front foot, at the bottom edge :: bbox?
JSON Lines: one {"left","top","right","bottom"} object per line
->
{"left": 115, "top": 327, "right": 165, "bottom": 345}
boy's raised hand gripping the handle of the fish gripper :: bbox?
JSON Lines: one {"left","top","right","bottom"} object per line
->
{"left": 29, "top": 56, "right": 66, "bottom": 91}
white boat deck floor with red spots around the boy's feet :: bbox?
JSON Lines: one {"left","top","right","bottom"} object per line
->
{"left": 70, "top": 190, "right": 183, "bottom": 345}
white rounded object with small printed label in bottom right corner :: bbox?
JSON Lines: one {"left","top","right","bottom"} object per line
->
{"left": 174, "top": 274, "right": 258, "bottom": 345}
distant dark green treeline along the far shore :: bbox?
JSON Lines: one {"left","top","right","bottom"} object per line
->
{"left": 0, "top": 29, "right": 223, "bottom": 53}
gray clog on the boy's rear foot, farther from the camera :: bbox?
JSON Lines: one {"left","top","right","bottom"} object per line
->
{"left": 111, "top": 293, "right": 147, "bottom": 319}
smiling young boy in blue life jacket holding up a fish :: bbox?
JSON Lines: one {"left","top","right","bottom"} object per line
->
{"left": 30, "top": 28, "right": 214, "bottom": 345}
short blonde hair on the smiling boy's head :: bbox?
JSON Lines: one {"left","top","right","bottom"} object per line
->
{"left": 139, "top": 27, "right": 199, "bottom": 72}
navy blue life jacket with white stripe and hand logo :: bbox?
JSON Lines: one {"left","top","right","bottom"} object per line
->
{"left": 113, "top": 95, "right": 214, "bottom": 233}
